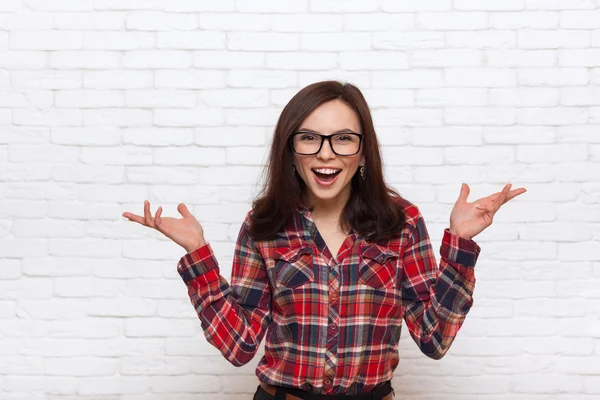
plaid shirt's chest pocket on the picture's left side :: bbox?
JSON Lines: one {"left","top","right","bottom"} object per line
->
{"left": 274, "top": 247, "right": 315, "bottom": 289}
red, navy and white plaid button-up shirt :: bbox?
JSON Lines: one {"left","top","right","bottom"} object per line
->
{"left": 178, "top": 199, "right": 480, "bottom": 394}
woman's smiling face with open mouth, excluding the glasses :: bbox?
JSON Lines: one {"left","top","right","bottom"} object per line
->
{"left": 294, "top": 99, "right": 364, "bottom": 204}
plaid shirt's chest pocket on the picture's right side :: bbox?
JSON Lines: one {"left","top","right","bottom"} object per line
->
{"left": 358, "top": 244, "right": 400, "bottom": 289}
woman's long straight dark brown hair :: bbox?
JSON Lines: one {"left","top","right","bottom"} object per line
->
{"left": 250, "top": 81, "right": 406, "bottom": 242}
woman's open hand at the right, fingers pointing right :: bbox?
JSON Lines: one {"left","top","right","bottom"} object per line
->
{"left": 450, "top": 183, "right": 527, "bottom": 239}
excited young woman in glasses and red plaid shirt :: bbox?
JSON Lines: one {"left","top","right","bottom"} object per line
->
{"left": 123, "top": 81, "right": 525, "bottom": 400}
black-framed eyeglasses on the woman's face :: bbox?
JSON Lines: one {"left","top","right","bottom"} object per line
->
{"left": 290, "top": 132, "right": 363, "bottom": 156}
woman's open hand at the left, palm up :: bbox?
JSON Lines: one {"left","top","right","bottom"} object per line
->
{"left": 123, "top": 200, "right": 206, "bottom": 253}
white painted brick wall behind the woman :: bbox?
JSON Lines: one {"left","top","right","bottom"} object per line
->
{"left": 0, "top": 0, "right": 600, "bottom": 400}
